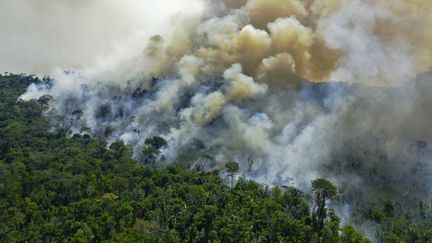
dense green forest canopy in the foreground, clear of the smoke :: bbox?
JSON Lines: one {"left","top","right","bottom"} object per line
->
{"left": 0, "top": 75, "right": 426, "bottom": 242}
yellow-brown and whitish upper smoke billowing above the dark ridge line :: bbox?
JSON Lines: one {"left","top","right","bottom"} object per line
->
{"left": 147, "top": 0, "right": 432, "bottom": 85}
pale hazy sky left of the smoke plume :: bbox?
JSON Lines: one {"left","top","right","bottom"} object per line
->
{"left": 0, "top": 0, "right": 200, "bottom": 74}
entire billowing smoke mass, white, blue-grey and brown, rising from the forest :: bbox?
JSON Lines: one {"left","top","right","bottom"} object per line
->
{"left": 22, "top": 0, "right": 432, "bottom": 201}
